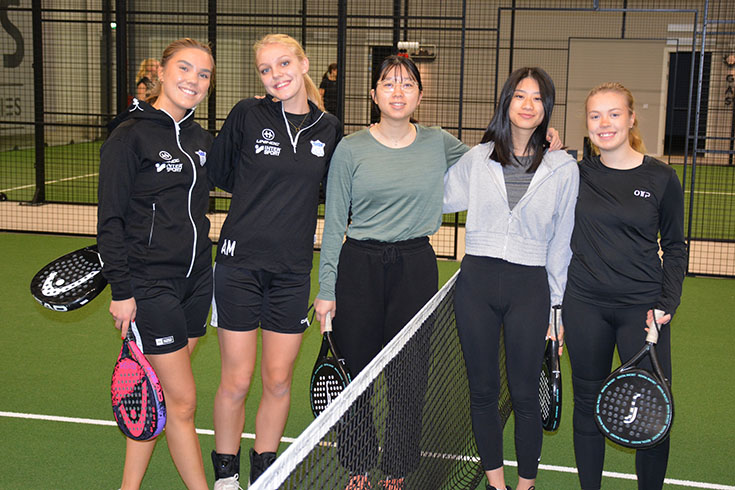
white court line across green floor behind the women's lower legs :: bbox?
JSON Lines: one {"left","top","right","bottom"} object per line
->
{"left": 0, "top": 411, "right": 735, "bottom": 490}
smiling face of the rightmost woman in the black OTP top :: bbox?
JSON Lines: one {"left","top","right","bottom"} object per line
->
{"left": 586, "top": 91, "right": 635, "bottom": 152}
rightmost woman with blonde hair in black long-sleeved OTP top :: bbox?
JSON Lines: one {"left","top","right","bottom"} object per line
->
{"left": 562, "top": 83, "right": 686, "bottom": 490}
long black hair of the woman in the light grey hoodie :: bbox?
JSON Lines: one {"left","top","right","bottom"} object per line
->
{"left": 480, "top": 67, "right": 556, "bottom": 172}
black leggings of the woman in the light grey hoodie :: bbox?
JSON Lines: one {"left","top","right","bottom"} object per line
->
{"left": 454, "top": 255, "right": 551, "bottom": 479}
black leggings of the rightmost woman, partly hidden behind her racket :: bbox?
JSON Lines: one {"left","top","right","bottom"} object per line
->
{"left": 562, "top": 294, "right": 671, "bottom": 490}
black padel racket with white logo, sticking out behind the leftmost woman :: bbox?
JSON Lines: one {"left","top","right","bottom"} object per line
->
{"left": 31, "top": 245, "right": 107, "bottom": 311}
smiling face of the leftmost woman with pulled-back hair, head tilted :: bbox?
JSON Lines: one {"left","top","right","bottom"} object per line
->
{"left": 153, "top": 48, "right": 214, "bottom": 121}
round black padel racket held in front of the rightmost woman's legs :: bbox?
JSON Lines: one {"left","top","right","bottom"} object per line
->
{"left": 595, "top": 310, "right": 674, "bottom": 448}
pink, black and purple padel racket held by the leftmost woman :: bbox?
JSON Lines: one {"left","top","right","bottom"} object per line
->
{"left": 110, "top": 325, "right": 166, "bottom": 441}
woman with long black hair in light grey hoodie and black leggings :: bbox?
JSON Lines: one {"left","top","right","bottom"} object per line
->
{"left": 444, "top": 68, "right": 579, "bottom": 490}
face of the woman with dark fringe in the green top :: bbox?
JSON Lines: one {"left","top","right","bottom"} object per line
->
{"left": 370, "top": 66, "right": 422, "bottom": 120}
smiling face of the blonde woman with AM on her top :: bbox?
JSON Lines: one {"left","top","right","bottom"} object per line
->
{"left": 255, "top": 43, "right": 309, "bottom": 114}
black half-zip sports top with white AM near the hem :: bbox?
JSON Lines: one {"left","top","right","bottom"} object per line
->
{"left": 207, "top": 97, "right": 342, "bottom": 273}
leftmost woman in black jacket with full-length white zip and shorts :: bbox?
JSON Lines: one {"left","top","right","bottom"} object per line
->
{"left": 97, "top": 38, "right": 214, "bottom": 489}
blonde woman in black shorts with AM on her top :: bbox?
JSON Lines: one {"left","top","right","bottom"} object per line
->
{"left": 210, "top": 34, "right": 342, "bottom": 490}
